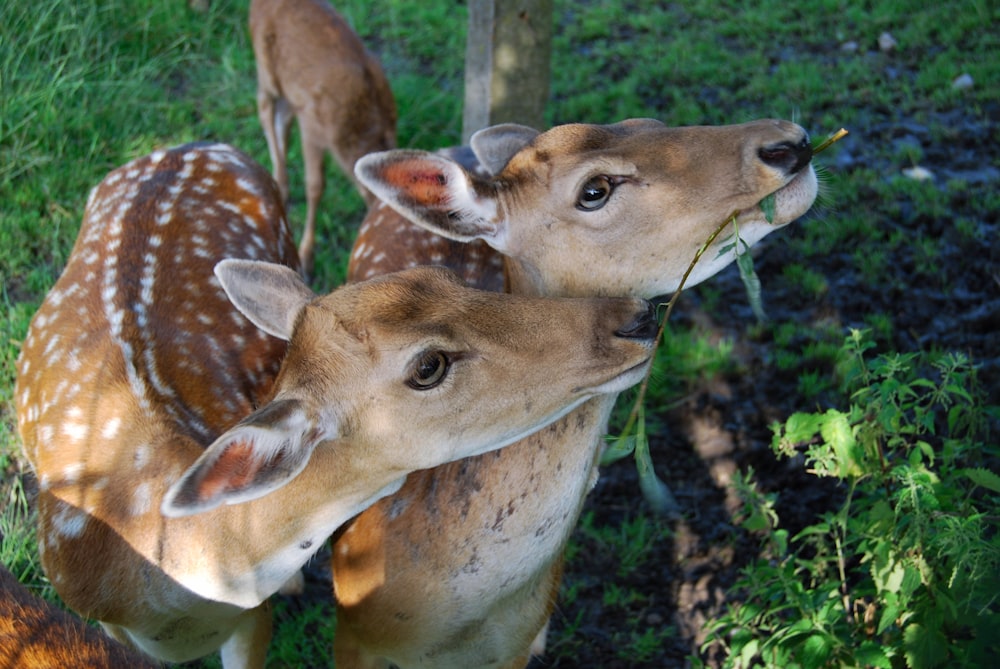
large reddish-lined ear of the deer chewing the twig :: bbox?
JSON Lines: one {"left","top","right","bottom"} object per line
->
{"left": 354, "top": 149, "right": 502, "bottom": 245}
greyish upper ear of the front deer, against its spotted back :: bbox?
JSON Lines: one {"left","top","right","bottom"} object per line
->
{"left": 215, "top": 258, "right": 315, "bottom": 341}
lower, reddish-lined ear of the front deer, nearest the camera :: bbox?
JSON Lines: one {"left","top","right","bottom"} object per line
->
{"left": 160, "top": 400, "right": 336, "bottom": 518}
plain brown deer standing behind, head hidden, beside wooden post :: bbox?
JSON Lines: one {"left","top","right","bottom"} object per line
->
{"left": 249, "top": 0, "right": 397, "bottom": 275}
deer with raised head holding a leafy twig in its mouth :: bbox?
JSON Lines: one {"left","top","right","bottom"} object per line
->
{"left": 332, "top": 120, "right": 817, "bottom": 669}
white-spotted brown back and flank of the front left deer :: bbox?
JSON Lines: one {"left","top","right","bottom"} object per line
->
{"left": 15, "top": 144, "right": 298, "bottom": 659}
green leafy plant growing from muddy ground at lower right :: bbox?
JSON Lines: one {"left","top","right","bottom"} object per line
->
{"left": 706, "top": 330, "right": 1000, "bottom": 669}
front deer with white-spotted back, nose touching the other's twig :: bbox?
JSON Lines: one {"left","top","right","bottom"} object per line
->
{"left": 15, "top": 143, "right": 656, "bottom": 668}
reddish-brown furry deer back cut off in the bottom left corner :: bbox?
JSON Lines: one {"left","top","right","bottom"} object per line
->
{"left": 0, "top": 566, "right": 159, "bottom": 669}
